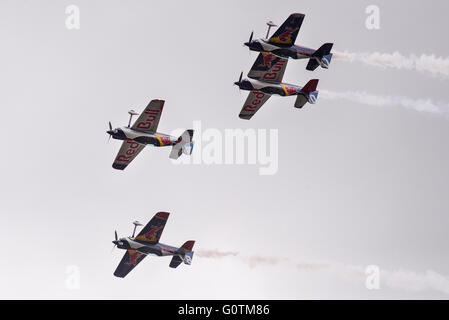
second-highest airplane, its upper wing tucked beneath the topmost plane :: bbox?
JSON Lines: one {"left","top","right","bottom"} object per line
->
{"left": 234, "top": 52, "right": 318, "bottom": 120}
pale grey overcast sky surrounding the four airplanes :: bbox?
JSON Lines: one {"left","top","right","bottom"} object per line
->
{"left": 0, "top": 0, "right": 449, "bottom": 299}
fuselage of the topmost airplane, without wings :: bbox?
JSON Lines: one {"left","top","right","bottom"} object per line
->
{"left": 245, "top": 39, "right": 316, "bottom": 59}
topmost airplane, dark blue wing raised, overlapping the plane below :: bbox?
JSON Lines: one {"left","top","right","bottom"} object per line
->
{"left": 244, "top": 13, "right": 333, "bottom": 71}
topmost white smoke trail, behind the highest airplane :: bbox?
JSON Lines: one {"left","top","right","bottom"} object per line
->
{"left": 333, "top": 51, "right": 449, "bottom": 77}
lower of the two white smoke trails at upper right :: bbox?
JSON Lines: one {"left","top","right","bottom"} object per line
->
{"left": 320, "top": 90, "right": 449, "bottom": 114}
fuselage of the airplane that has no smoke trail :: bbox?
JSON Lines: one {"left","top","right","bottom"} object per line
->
{"left": 108, "top": 127, "right": 179, "bottom": 147}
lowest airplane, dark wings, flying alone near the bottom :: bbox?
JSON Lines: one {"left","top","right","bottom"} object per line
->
{"left": 112, "top": 212, "right": 195, "bottom": 278}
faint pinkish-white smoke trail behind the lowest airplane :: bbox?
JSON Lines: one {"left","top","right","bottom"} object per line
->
{"left": 196, "top": 250, "right": 449, "bottom": 294}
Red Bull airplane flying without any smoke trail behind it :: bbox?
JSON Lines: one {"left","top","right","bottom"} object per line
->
{"left": 106, "top": 99, "right": 193, "bottom": 170}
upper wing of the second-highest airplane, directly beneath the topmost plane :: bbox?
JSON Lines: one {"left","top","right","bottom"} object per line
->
{"left": 248, "top": 52, "right": 288, "bottom": 83}
